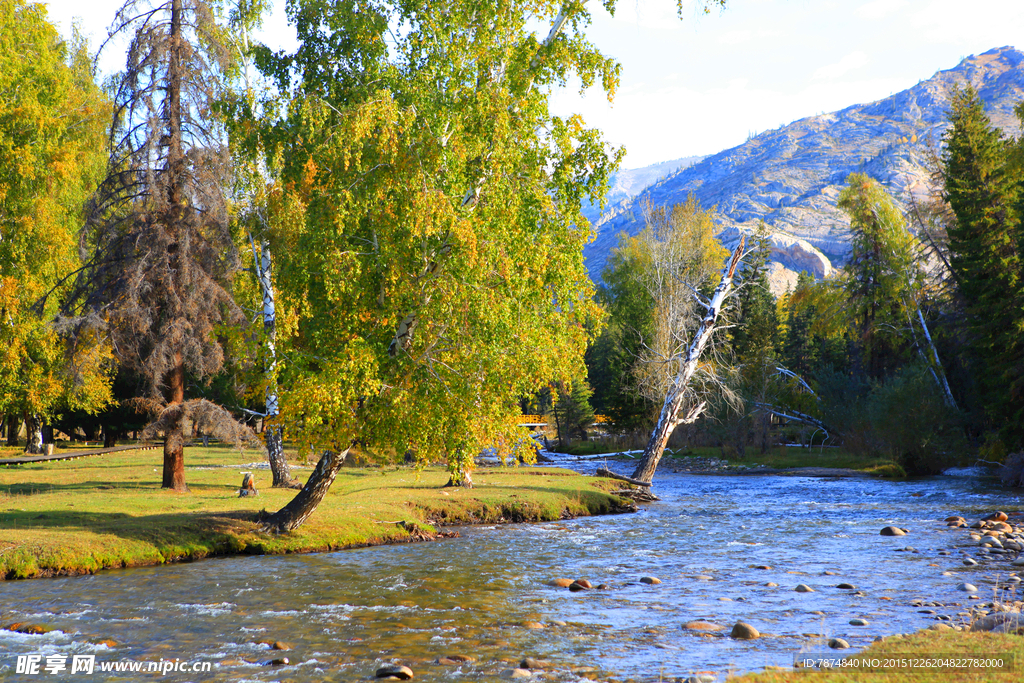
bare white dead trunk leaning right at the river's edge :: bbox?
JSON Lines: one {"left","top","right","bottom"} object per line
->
{"left": 632, "top": 237, "right": 744, "bottom": 482}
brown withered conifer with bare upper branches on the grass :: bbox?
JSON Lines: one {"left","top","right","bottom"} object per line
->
{"left": 67, "top": 0, "right": 245, "bottom": 492}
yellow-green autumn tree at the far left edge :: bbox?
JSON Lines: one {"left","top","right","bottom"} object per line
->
{"left": 0, "top": 0, "right": 112, "bottom": 453}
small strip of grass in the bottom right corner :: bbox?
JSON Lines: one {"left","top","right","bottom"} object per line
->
{"left": 728, "top": 631, "right": 1024, "bottom": 683}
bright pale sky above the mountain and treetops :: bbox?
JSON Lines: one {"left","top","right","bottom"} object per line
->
{"left": 41, "top": 0, "right": 1024, "bottom": 168}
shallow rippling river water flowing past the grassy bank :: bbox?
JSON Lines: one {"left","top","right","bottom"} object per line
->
{"left": 0, "top": 465, "right": 1017, "bottom": 682}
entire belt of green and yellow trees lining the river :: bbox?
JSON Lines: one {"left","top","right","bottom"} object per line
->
{"left": 0, "top": 0, "right": 1024, "bottom": 530}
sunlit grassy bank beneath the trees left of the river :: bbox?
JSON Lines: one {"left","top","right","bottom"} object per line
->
{"left": 0, "top": 446, "right": 622, "bottom": 579}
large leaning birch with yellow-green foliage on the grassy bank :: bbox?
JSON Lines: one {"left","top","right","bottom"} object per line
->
{"left": 238, "top": 0, "right": 617, "bottom": 530}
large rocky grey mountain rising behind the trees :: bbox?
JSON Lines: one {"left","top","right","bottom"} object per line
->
{"left": 584, "top": 47, "right": 1024, "bottom": 293}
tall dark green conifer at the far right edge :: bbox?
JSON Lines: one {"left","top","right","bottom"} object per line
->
{"left": 942, "top": 87, "right": 1024, "bottom": 443}
